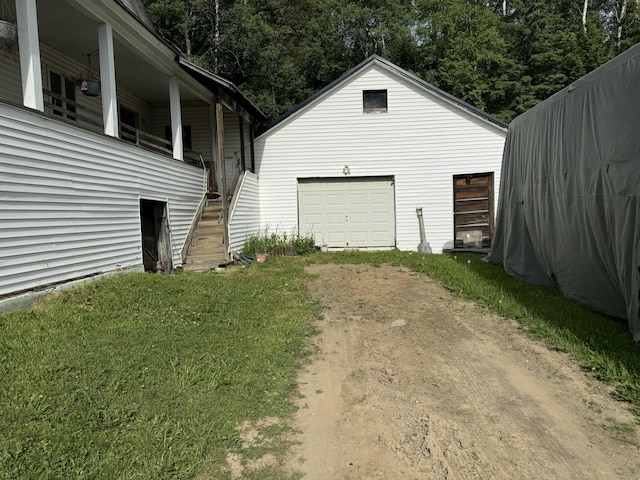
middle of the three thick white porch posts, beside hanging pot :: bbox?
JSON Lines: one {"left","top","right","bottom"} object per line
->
{"left": 98, "top": 23, "right": 120, "bottom": 137}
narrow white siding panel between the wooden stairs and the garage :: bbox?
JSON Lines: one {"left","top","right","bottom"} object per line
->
{"left": 228, "top": 172, "right": 260, "bottom": 252}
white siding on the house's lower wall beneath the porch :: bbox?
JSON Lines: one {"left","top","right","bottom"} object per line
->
{"left": 0, "top": 105, "right": 204, "bottom": 295}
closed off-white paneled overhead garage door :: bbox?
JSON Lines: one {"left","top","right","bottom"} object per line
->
{"left": 298, "top": 177, "right": 396, "bottom": 248}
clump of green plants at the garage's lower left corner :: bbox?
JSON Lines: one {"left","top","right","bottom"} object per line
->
{"left": 242, "top": 227, "right": 316, "bottom": 257}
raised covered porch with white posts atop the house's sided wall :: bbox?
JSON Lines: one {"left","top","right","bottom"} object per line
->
{"left": 0, "top": 0, "right": 264, "bottom": 197}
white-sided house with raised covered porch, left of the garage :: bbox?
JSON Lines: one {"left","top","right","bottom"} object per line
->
{"left": 0, "top": 0, "right": 264, "bottom": 298}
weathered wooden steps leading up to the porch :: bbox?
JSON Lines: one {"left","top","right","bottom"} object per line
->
{"left": 182, "top": 198, "right": 227, "bottom": 272}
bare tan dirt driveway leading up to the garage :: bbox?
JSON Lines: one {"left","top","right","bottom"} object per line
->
{"left": 287, "top": 265, "right": 640, "bottom": 480}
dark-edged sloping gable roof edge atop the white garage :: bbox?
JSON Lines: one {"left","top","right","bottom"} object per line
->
{"left": 269, "top": 55, "right": 508, "bottom": 129}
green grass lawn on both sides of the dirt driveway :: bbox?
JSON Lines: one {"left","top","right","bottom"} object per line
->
{"left": 0, "top": 251, "right": 640, "bottom": 479}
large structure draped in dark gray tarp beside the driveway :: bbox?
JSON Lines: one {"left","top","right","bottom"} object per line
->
{"left": 488, "top": 44, "right": 640, "bottom": 342}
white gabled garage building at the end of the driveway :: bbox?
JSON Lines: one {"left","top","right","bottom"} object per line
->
{"left": 229, "top": 56, "right": 507, "bottom": 253}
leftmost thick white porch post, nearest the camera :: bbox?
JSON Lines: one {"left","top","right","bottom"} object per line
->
{"left": 16, "top": 0, "right": 44, "bottom": 112}
